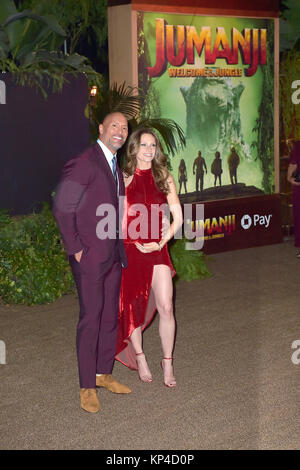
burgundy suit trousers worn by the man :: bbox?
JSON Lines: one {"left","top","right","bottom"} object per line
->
{"left": 69, "top": 250, "right": 122, "bottom": 388}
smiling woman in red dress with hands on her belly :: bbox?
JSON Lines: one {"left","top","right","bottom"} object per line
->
{"left": 116, "top": 129, "right": 182, "bottom": 387}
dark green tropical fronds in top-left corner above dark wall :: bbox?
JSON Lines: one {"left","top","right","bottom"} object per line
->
{"left": 0, "top": 0, "right": 102, "bottom": 95}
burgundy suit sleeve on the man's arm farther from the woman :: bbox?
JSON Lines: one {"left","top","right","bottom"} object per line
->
{"left": 53, "top": 157, "right": 91, "bottom": 255}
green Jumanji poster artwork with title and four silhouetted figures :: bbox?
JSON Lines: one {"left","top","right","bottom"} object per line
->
{"left": 137, "top": 12, "right": 274, "bottom": 202}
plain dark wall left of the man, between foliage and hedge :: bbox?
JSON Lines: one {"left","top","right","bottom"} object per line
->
{"left": 0, "top": 74, "right": 89, "bottom": 214}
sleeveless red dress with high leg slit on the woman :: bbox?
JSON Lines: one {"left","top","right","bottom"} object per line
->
{"left": 116, "top": 168, "right": 175, "bottom": 369}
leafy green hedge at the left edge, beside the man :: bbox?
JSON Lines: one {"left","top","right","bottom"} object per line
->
{"left": 0, "top": 204, "right": 74, "bottom": 305}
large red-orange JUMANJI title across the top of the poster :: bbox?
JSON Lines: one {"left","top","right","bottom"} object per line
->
{"left": 147, "top": 18, "right": 267, "bottom": 77}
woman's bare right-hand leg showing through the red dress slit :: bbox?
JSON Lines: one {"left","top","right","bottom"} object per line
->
{"left": 152, "top": 264, "right": 176, "bottom": 387}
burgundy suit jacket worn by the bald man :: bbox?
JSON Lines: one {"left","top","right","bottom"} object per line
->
{"left": 53, "top": 143, "right": 127, "bottom": 267}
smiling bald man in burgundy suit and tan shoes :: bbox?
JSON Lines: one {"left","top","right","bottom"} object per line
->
{"left": 53, "top": 113, "right": 131, "bottom": 413}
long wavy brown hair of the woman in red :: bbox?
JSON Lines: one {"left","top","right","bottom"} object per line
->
{"left": 124, "top": 128, "right": 169, "bottom": 194}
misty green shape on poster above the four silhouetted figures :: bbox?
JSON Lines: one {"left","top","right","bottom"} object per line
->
{"left": 180, "top": 77, "right": 248, "bottom": 156}
